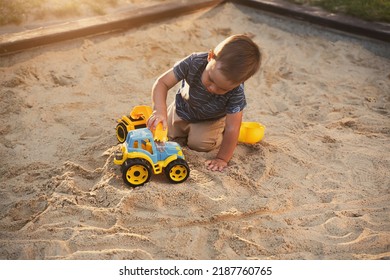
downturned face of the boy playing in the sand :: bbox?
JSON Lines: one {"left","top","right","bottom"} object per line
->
{"left": 202, "top": 58, "right": 240, "bottom": 95}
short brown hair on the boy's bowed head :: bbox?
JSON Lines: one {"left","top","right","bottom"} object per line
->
{"left": 212, "top": 34, "right": 261, "bottom": 83}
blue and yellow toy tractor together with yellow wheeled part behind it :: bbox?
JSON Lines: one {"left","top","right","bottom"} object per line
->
{"left": 114, "top": 106, "right": 190, "bottom": 187}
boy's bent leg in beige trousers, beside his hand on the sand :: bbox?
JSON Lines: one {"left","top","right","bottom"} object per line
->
{"left": 187, "top": 118, "right": 226, "bottom": 152}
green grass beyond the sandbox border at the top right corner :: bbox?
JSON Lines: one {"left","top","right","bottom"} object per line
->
{"left": 287, "top": 0, "right": 390, "bottom": 22}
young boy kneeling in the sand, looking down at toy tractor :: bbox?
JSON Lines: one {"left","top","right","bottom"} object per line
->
{"left": 147, "top": 35, "right": 261, "bottom": 171}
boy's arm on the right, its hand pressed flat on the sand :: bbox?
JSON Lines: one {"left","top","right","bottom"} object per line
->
{"left": 206, "top": 111, "right": 243, "bottom": 171}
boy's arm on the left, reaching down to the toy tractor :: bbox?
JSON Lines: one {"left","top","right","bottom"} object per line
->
{"left": 147, "top": 68, "right": 179, "bottom": 129}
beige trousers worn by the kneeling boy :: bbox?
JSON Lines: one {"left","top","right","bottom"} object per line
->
{"left": 168, "top": 102, "right": 226, "bottom": 152}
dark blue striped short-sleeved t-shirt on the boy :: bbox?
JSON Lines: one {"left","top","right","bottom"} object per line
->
{"left": 173, "top": 53, "right": 246, "bottom": 122}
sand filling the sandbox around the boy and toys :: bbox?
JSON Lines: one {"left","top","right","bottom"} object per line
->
{"left": 0, "top": 1, "right": 390, "bottom": 259}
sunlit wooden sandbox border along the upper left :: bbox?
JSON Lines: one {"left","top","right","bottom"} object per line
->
{"left": 0, "top": 0, "right": 224, "bottom": 55}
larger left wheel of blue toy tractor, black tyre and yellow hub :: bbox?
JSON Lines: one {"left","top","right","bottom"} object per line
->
{"left": 122, "top": 158, "right": 152, "bottom": 187}
